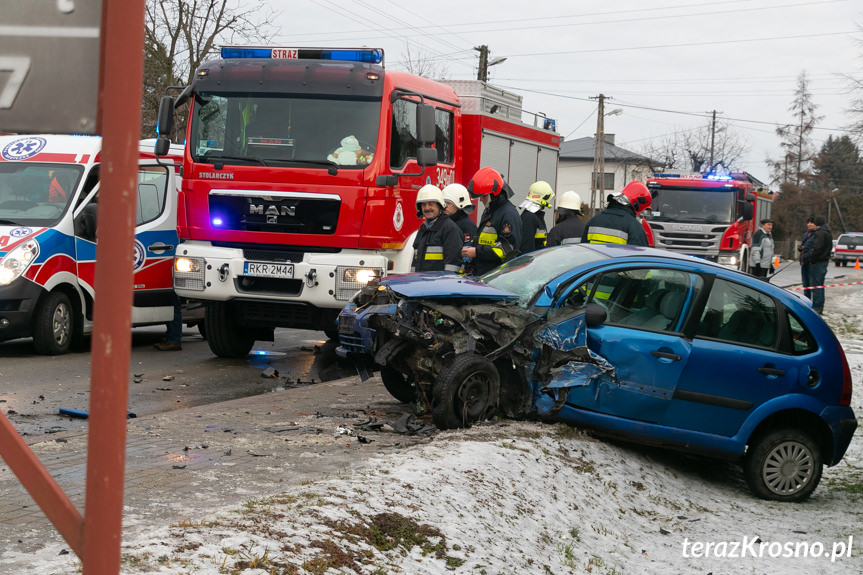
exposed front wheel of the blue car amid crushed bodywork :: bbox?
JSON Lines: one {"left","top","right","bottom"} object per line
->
{"left": 432, "top": 353, "right": 500, "bottom": 429}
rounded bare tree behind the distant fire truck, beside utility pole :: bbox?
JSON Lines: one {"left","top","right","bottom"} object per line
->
{"left": 642, "top": 119, "right": 749, "bottom": 173}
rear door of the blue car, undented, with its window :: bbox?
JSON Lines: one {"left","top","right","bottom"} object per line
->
{"left": 666, "top": 278, "right": 807, "bottom": 436}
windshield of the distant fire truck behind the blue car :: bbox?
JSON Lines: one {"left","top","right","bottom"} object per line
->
{"left": 650, "top": 187, "right": 737, "bottom": 224}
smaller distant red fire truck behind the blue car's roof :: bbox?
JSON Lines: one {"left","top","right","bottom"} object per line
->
{"left": 646, "top": 172, "right": 772, "bottom": 271}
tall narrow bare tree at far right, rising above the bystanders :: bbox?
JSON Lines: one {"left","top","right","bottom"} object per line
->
{"left": 767, "top": 71, "right": 824, "bottom": 187}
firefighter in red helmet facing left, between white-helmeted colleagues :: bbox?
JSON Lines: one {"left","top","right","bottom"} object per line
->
{"left": 461, "top": 167, "right": 521, "bottom": 274}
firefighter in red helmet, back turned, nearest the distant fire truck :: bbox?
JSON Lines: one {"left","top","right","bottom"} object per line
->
{"left": 581, "top": 182, "right": 651, "bottom": 247}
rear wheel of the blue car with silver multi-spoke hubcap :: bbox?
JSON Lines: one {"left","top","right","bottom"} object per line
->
{"left": 743, "top": 429, "right": 823, "bottom": 501}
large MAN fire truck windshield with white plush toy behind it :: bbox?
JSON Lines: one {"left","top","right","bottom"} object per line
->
{"left": 189, "top": 92, "right": 381, "bottom": 169}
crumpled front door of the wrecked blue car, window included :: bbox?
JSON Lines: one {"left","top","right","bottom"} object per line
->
{"left": 539, "top": 267, "right": 703, "bottom": 423}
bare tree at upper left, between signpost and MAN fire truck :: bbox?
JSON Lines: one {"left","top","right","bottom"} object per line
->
{"left": 141, "top": 0, "right": 278, "bottom": 137}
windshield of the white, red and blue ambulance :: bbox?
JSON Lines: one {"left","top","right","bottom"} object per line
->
{"left": 0, "top": 162, "right": 83, "bottom": 226}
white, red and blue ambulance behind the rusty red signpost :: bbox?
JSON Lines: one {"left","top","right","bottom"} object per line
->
{"left": 0, "top": 135, "right": 182, "bottom": 355}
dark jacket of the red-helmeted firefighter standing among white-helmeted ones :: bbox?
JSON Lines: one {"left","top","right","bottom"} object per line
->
{"left": 474, "top": 196, "right": 521, "bottom": 274}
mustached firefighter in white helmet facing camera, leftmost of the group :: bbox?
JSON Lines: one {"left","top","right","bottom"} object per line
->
{"left": 411, "top": 184, "right": 462, "bottom": 272}
